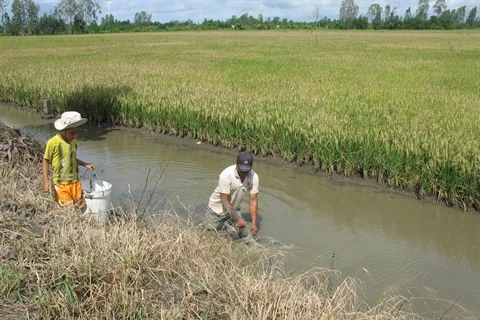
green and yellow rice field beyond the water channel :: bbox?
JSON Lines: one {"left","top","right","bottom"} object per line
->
{"left": 0, "top": 31, "right": 480, "bottom": 210}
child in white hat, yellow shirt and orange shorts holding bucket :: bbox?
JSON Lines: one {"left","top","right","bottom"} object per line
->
{"left": 42, "top": 111, "right": 94, "bottom": 207}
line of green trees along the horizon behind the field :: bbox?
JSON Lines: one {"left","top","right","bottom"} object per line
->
{"left": 0, "top": 0, "right": 480, "bottom": 36}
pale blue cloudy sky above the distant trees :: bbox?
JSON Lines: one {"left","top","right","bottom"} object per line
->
{"left": 34, "top": 0, "right": 480, "bottom": 23}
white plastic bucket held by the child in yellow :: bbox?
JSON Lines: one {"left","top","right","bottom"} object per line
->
{"left": 82, "top": 180, "right": 112, "bottom": 216}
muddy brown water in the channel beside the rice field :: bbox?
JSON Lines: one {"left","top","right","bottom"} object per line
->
{"left": 0, "top": 104, "right": 480, "bottom": 318}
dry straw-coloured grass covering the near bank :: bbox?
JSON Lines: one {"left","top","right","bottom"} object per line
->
{"left": 0, "top": 121, "right": 472, "bottom": 319}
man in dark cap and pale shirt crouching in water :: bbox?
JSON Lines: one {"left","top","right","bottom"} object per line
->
{"left": 205, "top": 151, "right": 259, "bottom": 239}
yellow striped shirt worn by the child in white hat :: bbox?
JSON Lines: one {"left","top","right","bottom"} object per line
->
{"left": 43, "top": 134, "right": 78, "bottom": 184}
